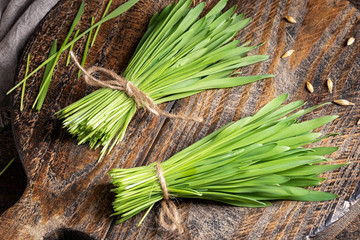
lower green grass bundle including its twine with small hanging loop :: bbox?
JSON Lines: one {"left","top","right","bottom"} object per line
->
{"left": 109, "top": 95, "right": 345, "bottom": 232}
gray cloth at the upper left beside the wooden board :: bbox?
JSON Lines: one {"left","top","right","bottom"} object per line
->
{"left": 0, "top": 0, "right": 59, "bottom": 127}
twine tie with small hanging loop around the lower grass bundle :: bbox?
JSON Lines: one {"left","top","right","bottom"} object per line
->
{"left": 155, "top": 163, "right": 184, "bottom": 233}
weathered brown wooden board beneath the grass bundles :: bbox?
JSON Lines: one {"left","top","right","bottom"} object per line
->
{"left": 0, "top": 0, "right": 360, "bottom": 240}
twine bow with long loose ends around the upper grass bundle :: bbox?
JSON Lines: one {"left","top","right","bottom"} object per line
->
{"left": 70, "top": 51, "right": 203, "bottom": 122}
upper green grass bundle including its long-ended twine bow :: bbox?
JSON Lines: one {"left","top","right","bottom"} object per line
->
{"left": 59, "top": 0, "right": 272, "bottom": 158}
